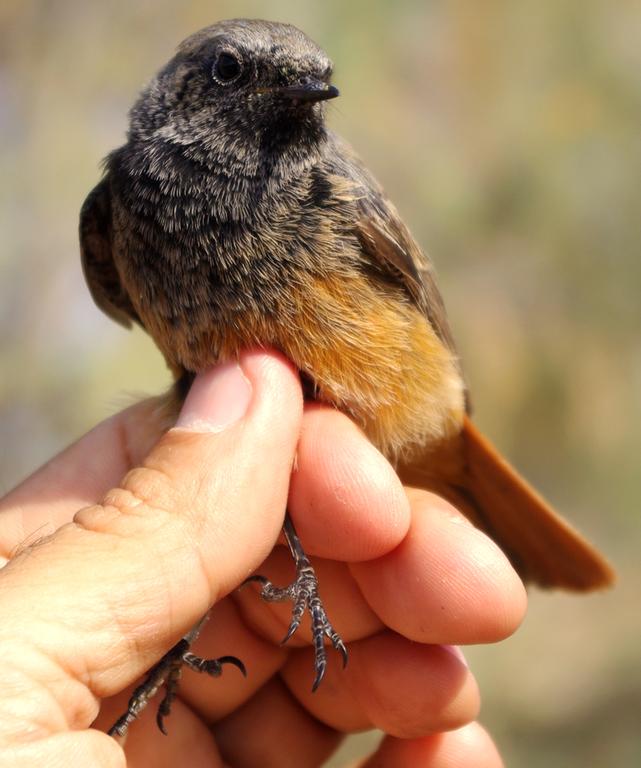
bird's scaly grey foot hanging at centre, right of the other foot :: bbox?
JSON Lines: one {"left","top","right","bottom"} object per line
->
{"left": 246, "top": 513, "right": 347, "bottom": 691}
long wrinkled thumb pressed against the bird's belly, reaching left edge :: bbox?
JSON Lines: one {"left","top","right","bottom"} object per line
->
{"left": 0, "top": 353, "right": 302, "bottom": 728}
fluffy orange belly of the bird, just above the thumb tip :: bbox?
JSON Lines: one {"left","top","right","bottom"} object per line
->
{"left": 143, "top": 273, "right": 465, "bottom": 460}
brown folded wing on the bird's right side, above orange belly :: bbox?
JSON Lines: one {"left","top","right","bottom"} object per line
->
{"left": 327, "top": 136, "right": 456, "bottom": 354}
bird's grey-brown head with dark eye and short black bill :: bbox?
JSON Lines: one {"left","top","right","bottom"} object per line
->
{"left": 130, "top": 19, "right": 338, "bottom": 173}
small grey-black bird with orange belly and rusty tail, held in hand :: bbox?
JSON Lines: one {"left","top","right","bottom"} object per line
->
{"left": 80, "top": 19, "right": 613, "bottom": 734}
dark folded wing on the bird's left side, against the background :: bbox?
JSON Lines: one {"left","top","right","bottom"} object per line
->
{"left": 80, "top": 175, "right": 140, "bottom": 328}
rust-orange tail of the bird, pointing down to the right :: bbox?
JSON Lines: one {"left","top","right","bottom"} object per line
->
{"left": 400, "top": 418, "right": 614, "bottom": 591}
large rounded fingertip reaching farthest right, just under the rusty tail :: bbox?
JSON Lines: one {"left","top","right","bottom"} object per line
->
{"left": 349, "top": 491, "right": 526, "bottom": 645}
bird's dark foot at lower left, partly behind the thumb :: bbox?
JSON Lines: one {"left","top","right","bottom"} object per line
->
{"left": 109, "top": 614, "right": 247, "bottom": 736}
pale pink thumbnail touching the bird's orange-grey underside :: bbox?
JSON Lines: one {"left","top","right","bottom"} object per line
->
{"left": 176, "top": 362, "right": 252, "bottom": 432}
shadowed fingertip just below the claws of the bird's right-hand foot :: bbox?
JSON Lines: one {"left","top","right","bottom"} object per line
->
{"left": 281, "top": 632, "right": 479, "bottom": 739}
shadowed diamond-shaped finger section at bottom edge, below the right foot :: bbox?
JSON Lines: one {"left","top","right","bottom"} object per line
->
{"left": 213, "top": 679, "right": 341, "bottom": 768}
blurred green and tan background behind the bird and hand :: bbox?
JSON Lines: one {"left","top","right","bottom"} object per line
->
{"left": 0, "top": 0, "right": 641, "bottom": 768}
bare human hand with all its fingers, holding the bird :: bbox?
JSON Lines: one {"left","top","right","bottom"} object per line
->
{"left": 0, "top": 352, "right": 526, "bottom": 768}
